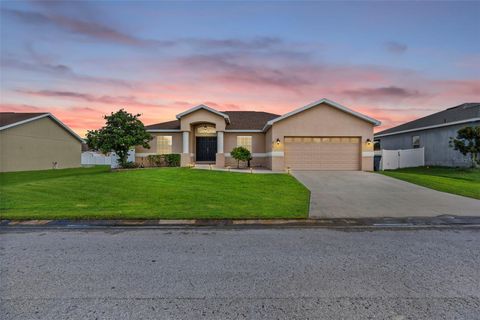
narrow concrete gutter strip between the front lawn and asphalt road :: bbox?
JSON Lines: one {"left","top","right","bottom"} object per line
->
{"left": 0, "top": 216, "right": 480, "bottom": 229}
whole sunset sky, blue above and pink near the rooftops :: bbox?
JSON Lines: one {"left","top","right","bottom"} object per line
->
{"left": 0, "top": 1, "right": 480, "bottom": 135}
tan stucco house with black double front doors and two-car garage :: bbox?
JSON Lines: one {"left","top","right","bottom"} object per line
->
{"left": 136, "top": 99, "right": 380, "bottom": 171}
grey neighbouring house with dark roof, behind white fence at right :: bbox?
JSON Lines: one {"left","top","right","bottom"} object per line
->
{"left": 375, "top": 102, "right": 480, "bottom": 166}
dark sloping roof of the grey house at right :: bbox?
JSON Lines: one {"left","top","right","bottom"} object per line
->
{"left": 375, "top": 102, "right": 480, "bottom": 136}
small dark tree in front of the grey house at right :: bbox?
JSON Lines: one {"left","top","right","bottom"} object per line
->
{"left": 450, "top": 126, "right": 480, "bottom": 167}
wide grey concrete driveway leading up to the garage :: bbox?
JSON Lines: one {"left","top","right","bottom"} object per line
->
{"left": 293, "top": 171, "right": 480, "bottom": 218}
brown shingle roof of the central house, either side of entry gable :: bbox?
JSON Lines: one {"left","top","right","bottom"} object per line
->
{"left": 145, "top": 111, "right": 280, "bottom": 130}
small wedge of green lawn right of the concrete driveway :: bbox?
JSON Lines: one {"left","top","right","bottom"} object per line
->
{"left": 381, "top": 167, "right": 480, "bottom": 199}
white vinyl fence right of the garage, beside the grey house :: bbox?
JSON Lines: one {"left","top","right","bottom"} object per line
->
{"left": 375, "top": 148, "right": 425, "bottom": 170}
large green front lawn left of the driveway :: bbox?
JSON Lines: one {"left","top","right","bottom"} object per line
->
{"left": 0, "top": 167, "right": 309, "bottom": 219}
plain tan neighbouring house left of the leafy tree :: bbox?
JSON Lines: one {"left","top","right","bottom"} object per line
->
{"left": 0, "top": 112, "right": 82, "bottom": 172}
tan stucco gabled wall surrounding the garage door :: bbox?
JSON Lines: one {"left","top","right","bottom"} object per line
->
{"left": 266, "top": 104, "right": 373, "bottom": 171}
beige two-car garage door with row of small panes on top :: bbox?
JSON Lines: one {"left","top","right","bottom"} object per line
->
{"left": 285, "top": 137, "right": 360, "bottom": 170}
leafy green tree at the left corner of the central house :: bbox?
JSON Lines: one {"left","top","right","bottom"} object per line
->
{"left": 86, "top": 109, "right": 153, "bottom": 167}
